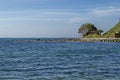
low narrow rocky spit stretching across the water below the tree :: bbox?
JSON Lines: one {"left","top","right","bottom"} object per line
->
{"left": 13, "top": 38, "right": 120, "bottom": 42}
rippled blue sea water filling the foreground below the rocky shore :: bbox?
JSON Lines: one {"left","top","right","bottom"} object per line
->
{"left": 0, "top": 40, "right": 120, "bottom": 80}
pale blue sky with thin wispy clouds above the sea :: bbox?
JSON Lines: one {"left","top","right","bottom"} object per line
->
{"left": 0, "top": 0, "right": 120, "bottom": 38}
